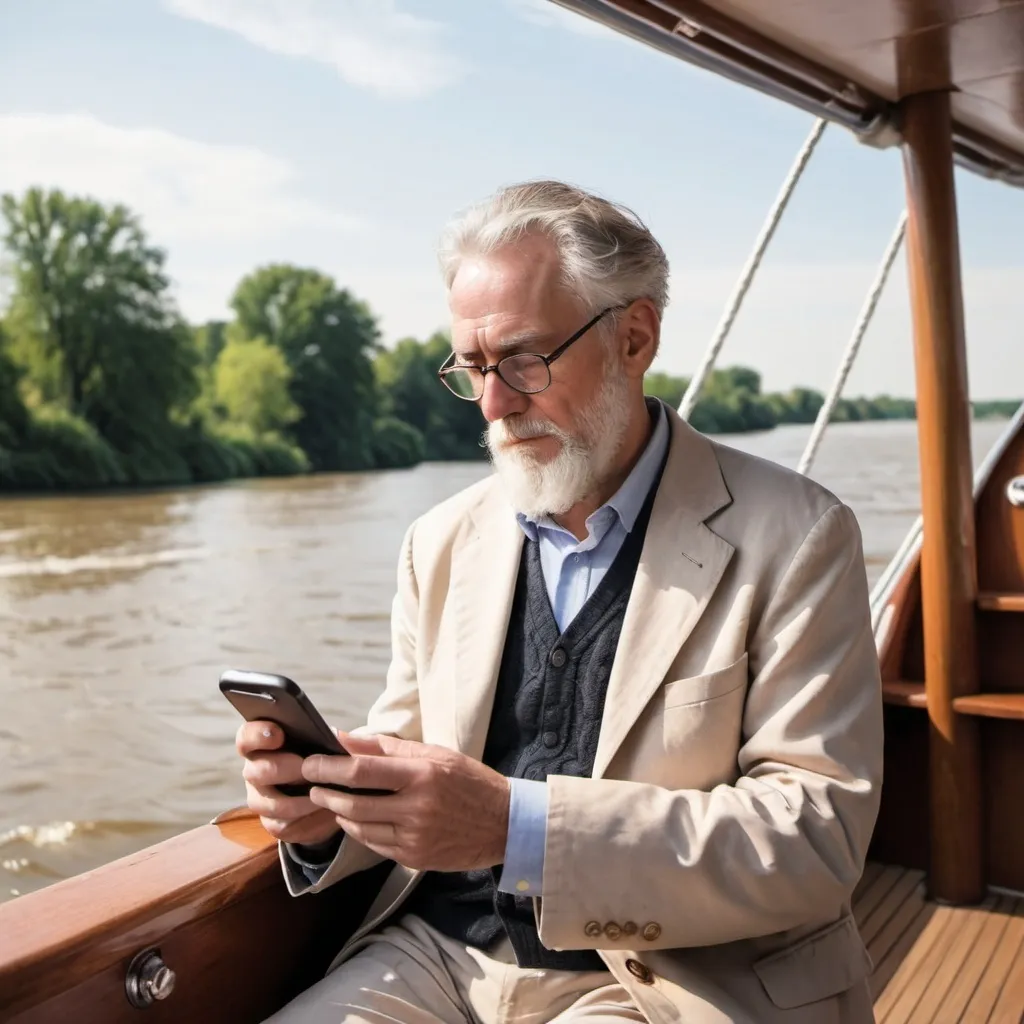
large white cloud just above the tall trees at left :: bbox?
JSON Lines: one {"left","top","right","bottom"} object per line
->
{"left": 0, "top": 114, "right": 357, "bottom": 245}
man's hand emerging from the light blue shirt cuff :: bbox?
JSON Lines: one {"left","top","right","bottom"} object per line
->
{"left": 302, "top": 732, "right": 510, "bottom": 871}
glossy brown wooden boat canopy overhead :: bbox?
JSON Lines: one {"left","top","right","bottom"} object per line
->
{"left": 555, "top": 0, "right": 1024, "bottom": 187}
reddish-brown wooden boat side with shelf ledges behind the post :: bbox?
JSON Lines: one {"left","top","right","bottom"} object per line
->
{"left": 872, "top": 385, "right": 1024, "bottom": 891}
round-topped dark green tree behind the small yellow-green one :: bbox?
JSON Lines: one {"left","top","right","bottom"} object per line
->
{"left": 231, "top": 264, "right": 379, "bottom": 470}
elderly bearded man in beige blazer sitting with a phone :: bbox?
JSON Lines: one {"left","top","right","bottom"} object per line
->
{"left": 239, "top": 181, "right": 882, "bottom": 1024}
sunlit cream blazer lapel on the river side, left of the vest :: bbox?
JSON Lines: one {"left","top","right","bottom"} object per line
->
{"left": 451, "top": 481, "right": 523, "bottom": 760}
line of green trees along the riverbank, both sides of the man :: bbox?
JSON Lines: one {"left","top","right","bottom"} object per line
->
{"left": 0, "top": 188, "right": 1014, "bottom": 490}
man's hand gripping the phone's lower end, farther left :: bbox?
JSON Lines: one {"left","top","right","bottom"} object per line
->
{"left": 234, "top": 722, "right": 339, "bottom": 846}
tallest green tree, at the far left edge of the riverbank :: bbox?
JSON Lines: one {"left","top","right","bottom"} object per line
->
{"left": 0, "top": 188, "right": 198, "bottom": 481}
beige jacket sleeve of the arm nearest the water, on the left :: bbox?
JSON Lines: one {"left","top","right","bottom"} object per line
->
{"left": 278, "top": 523, "right": 422, "bottom": 896}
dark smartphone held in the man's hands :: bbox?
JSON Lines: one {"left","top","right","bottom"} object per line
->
{"left": 220, "top": 669, "right": 390, "bottom": 797}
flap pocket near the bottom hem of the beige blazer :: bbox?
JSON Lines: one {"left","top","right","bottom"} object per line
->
{"left": 754, "top": 914, "right": 873, "bottom": 1010}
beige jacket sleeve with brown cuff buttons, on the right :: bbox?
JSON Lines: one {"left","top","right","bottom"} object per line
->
{"left": 535, "top": 504, "right": 883, "bottom": 949}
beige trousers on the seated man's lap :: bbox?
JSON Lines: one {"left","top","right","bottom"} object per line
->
{"left": 264, "top": 914, "right": 645, "bottom": 1024}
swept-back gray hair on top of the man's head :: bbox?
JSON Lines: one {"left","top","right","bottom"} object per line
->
{"left": 438, "top": 181, "right": 669, "bottom": 316}
